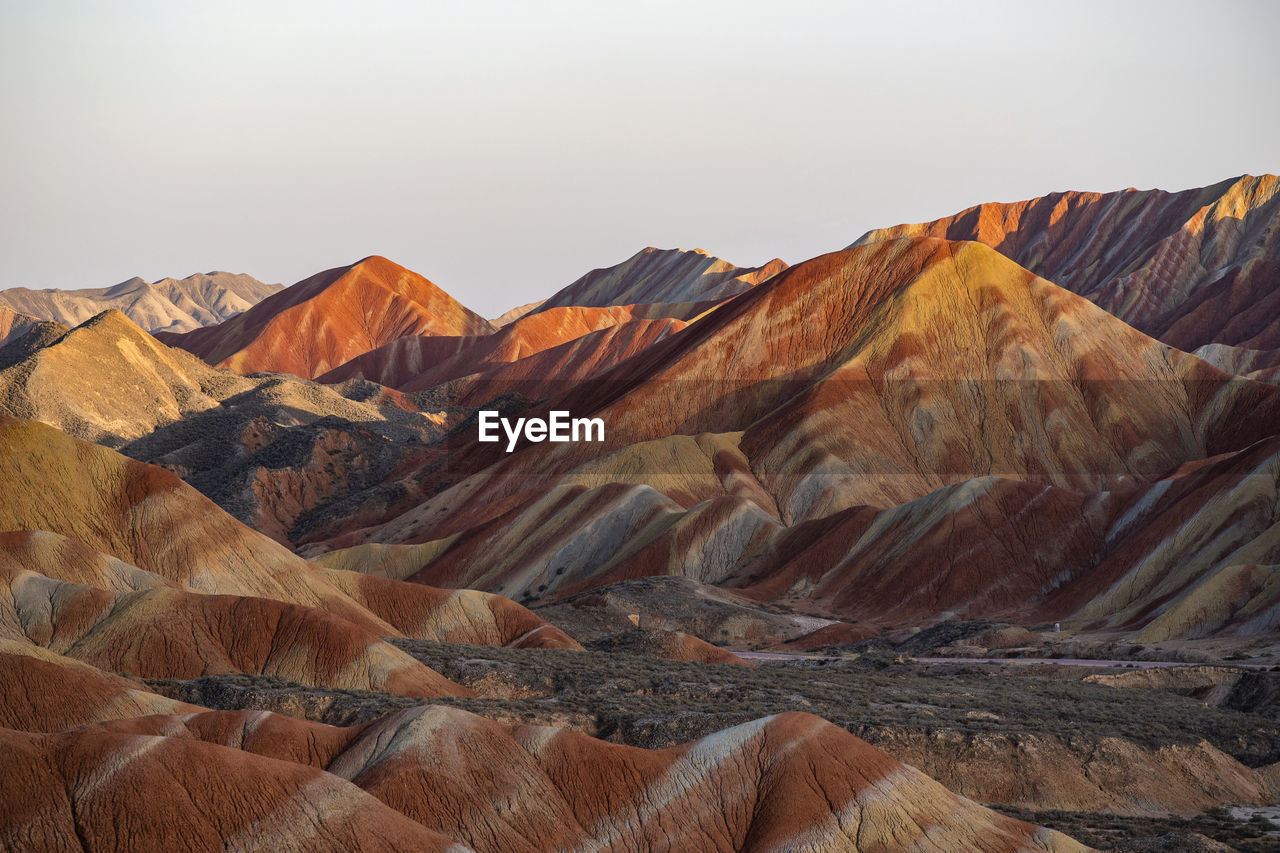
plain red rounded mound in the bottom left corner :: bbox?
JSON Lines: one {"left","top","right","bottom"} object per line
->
{"left": 0, "top": 729, "right": 452, "bottom": 853}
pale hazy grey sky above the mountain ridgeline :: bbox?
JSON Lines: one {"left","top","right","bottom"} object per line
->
{"left": 0, "top": 0, "right": 1280, "bottom": 315}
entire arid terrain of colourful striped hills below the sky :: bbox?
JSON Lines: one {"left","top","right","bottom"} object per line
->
{"left": 0, "top": 175, "right": 1280, "bottom": 853}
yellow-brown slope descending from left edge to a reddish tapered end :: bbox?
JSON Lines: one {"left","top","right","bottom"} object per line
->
{"left": 0, "top": 418, "right": 577, "bottom": 650}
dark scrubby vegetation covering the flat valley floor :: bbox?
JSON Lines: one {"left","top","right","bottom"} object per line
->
{"left": 148, "top": 639, "right": 1280, "bottom": 850}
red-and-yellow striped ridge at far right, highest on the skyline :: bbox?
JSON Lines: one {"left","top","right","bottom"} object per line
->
{"left": 854, "top": 174, "right": 1280, "bottom": 364}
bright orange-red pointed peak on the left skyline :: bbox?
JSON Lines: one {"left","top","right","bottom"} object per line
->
{"left": 160, "top": 255, "right": 494, "bottom": 379}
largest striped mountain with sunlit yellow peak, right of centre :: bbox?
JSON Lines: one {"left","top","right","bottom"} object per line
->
{"left": 309, "top": 238, "right": 1280, "bottom": 637}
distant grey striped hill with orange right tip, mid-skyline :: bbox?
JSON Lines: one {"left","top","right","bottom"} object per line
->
{"left": 536, "top": 247, "right": 787, "bottom": 313}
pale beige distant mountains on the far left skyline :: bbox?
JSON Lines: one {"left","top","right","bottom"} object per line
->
{"left": 0, "top": 273, "right": 283, "bottom": 332}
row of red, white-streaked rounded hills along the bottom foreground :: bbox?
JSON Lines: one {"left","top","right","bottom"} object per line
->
{"left": 0, "top": 707, "right": 1085, "bottom": 853}
